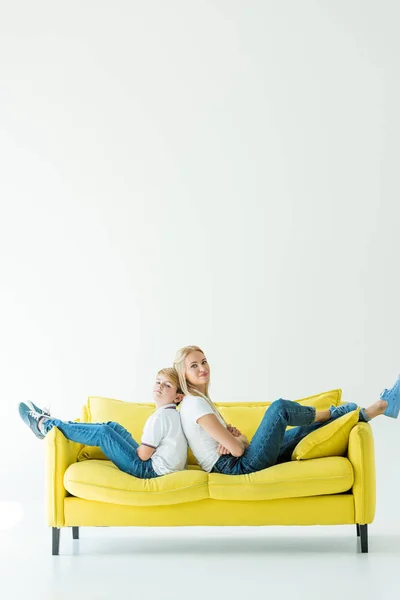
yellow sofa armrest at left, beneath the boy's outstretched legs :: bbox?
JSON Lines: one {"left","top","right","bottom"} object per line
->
{"left": 46, "top": 427, "right": 83, "bottom": 527}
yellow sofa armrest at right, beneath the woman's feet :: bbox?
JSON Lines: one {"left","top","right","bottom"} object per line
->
{"left": 348, "top": 422, "right": 376, "bottom": 525}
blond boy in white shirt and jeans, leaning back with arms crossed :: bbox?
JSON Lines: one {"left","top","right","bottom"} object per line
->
{"left": 19, "top": 368, "right": 187, "bottom": 479}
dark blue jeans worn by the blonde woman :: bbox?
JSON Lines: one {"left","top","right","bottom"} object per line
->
{"left": 212, "top": 398, "right": 369, "bottom": 475}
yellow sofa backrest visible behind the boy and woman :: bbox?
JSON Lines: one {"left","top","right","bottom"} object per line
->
{"left": 78, "top": 389, "right": 342, "bottom": 465}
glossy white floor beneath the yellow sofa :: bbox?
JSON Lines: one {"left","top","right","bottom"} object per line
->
{"left": 0, "top": 523, "right": 400, "bottom": 600}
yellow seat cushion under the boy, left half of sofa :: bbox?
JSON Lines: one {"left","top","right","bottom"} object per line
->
{"left": 64, "top": 460, "right": 209, "bottom": 506}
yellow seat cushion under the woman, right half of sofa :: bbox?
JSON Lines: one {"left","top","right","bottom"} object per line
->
{"left": 208, "top": 456, "right": 354, "bottom": 500}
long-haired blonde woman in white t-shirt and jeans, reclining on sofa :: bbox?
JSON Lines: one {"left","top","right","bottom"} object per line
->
{"left": 174, "top": 346, "right": 400, "bottom": 475}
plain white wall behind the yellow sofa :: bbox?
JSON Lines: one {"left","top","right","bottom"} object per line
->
{"left": 0, "top": 0, "right": 400, "bottom": 528}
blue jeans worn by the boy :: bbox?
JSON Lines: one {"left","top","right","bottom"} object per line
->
{"left": 43, "top": 419, "right": 158, "bottom": 479}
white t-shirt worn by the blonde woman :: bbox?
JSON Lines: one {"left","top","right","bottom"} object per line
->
{"left": 180, "top": 394, "right": 226, "bottom": 473}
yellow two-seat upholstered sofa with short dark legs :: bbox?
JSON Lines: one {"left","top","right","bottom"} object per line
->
{"left": 46, "top": 390, "right": 375, "bottom": 555}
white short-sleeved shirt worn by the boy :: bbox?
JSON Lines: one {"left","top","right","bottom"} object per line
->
{"left": 142, "top": 404, "right": 187, "bottom": 475}
